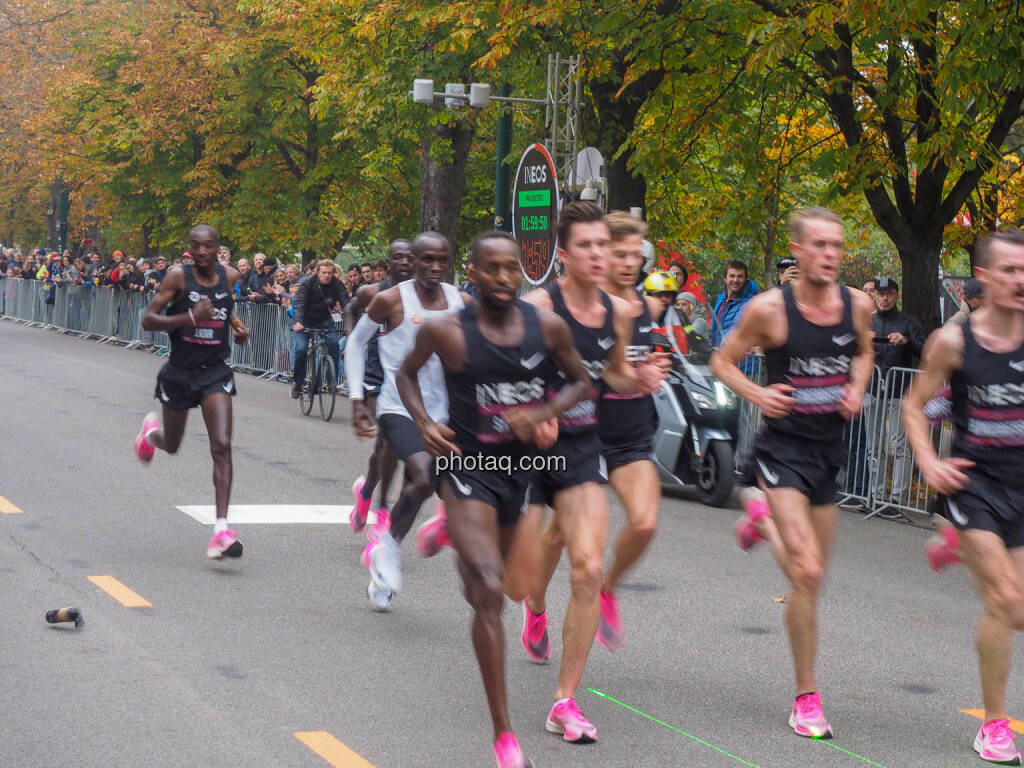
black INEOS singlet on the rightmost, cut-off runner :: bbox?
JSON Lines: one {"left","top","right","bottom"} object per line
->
{"left": 949, "top": 317, "right": 1024, "bottom": 487}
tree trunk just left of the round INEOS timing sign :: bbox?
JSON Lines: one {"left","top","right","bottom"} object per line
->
{"left": 420, "top": 121, "right": 473, "bottom": 274}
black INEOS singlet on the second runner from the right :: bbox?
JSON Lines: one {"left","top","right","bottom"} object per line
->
{"left": 765, "top": 285, "right": 858, "bottom": 442}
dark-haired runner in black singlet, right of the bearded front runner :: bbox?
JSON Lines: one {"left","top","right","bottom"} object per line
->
{"left": 522, "top": 202, "right": 668, "bottom": 743}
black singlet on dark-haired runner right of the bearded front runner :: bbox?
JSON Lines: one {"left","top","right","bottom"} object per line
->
{"left": 547, "top": 282, "right": 617, "bottom": 434}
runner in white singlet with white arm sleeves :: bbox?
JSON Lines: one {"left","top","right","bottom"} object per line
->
{"left": 345, "top": 232, "right": 468, "bottom": 610}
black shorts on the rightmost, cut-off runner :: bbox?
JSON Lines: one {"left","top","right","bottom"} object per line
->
{"left": 946, "top": 467, "right": 1024, "bottom": 549}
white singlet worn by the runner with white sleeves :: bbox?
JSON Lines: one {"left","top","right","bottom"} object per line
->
{"left": 377, "top": 280, "right": 463, "bottom": 423}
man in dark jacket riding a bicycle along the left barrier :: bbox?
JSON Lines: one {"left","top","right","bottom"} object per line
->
{"left": 292, "top": 259, "right": 348, "bottom": 399}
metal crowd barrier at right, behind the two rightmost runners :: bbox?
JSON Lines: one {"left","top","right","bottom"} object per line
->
{"left": 736, "top": 356, "right": 952, "bottom": 521}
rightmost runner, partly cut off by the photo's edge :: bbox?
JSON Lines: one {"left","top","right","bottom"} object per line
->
{"left": 903, "top": 229, "right": 1024, "bottom": 765}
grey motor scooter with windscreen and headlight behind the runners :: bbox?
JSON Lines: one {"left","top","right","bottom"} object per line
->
{"left": 653, "top": 309, "right": 739, "bottom": 507}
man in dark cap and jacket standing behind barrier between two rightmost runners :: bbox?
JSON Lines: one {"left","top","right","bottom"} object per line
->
{"left": 864, "top": 278, "right": 925, "bottom": 516}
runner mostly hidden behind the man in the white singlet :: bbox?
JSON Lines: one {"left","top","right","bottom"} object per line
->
{"left": 344, "top": 239, "right": 413, "bottom": 538}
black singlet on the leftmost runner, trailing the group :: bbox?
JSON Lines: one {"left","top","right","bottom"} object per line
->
{"left": 167, "top": 264, "right": 234, "bottom": 371}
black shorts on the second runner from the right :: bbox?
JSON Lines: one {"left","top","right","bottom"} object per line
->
{"left": 742, "top": 431, "right": 847, "bottom": 507}
